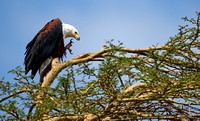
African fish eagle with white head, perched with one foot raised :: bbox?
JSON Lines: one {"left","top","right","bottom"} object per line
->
{"left": 24, "top": 18, "right": 80, "bottom": 77}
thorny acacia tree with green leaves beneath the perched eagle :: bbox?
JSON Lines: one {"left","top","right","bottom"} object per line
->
{"left": 0, "top": 12, "right": 200, "bottom": 121}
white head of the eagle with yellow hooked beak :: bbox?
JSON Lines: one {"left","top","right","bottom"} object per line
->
{"left": 62, "top": 23, "right": 80, "bottom": 40}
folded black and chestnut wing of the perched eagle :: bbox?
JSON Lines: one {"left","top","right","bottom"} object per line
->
{"left": 24, "top": 18, "right": 63, "bottom": 76}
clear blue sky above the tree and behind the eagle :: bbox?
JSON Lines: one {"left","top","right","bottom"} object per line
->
{"left": 0, "top": 0, "right": 200, "bottom": 82}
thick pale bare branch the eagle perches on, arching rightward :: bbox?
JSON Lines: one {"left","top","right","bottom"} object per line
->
{"left": 42, "top": 46, "right": 177, "bottom": 87}
